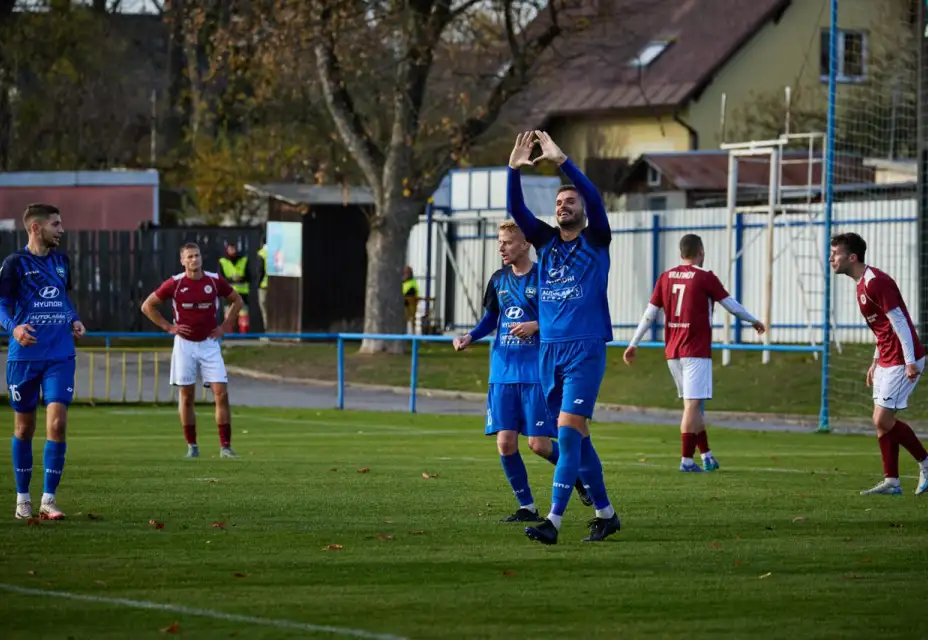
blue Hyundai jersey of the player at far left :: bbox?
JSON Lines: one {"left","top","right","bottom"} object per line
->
{"left": 0, "top": 249, "right": 78, "bottom": 361}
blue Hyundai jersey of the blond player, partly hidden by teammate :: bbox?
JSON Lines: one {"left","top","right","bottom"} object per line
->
{"left": 483, "top": 265, "right": 539, "bottom": 384}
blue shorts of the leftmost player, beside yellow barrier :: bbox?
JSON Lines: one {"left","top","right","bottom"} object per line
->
{"left": 6, "top": 358, "right": 77, "bottom": 413}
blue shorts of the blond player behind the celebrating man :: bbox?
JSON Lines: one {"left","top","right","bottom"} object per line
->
{"left": 486, "top": 383, "right": 557, "bottom": 438}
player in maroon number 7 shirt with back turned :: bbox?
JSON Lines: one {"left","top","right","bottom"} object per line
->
{"left": 623, "top": 233, "right": 766, "bottom": 472}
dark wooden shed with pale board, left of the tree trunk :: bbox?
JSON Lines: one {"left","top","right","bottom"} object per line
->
{"left": 245, "top": 183, "right": 374, "bottom": 333}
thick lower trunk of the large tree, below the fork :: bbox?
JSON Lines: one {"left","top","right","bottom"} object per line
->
{"left": 361, "top": 201, "right": 421, "bottom": 353}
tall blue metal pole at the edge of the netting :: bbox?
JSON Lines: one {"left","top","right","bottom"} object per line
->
{"left": 818, "top": 0, "right": 838, "bottom": 433}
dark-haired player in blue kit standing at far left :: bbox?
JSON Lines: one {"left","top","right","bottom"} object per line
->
{"left": 0, "top": 204, "right": 84, "bottom": 520}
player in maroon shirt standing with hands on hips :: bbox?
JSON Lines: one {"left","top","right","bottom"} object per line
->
{"left": 142, "top": 243, "right": 243, "bottom": 458}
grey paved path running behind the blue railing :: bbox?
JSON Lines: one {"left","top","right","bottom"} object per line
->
{"left": 0, "top": 352, "right": 900, "bottom": 433}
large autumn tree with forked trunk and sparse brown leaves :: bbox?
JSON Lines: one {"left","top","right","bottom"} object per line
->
{"left": 237, "top": 0, "right": 581, "bottom": 352}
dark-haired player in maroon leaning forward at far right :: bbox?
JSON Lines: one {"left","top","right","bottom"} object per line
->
{"left": 831, "top": 233, "right": 928, "bottom": 495}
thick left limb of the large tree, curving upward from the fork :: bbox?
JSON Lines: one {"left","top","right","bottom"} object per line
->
{"left": 314, "top": 1, "right": 384, "bottom": 202}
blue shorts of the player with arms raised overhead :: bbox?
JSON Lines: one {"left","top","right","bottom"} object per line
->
{"left": 539, "top": 338, "right": 606, "bottom": 418}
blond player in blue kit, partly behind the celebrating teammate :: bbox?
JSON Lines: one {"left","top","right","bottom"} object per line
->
{"left": 453, "top": 220, "right": 592, "bottom": 522}
